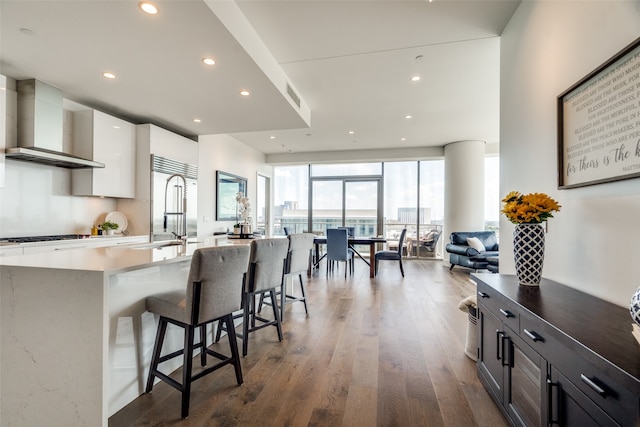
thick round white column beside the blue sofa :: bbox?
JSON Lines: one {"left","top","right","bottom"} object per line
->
{"left": 442, "top": 141, "right": 485, "bottom": 266}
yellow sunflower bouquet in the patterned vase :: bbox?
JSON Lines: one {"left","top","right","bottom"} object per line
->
{"left": 501, "top": 191, "right": 562, "bottom": 224}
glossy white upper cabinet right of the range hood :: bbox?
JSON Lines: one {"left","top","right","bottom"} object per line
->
{"left": 71, "top": 110, "right": 136, "bottom": 198}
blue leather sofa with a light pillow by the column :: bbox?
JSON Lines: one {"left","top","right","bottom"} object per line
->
{"left": 445, "top": 231, "right": 499, "bottom": 272}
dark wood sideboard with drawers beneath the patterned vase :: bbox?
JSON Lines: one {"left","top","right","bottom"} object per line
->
{"left": 471, "top": 273, "right": 640, "bottom": 427}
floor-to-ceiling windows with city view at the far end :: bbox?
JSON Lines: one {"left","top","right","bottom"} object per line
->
{"left": 273, "top": 157, "right": 500, "bottom": 258}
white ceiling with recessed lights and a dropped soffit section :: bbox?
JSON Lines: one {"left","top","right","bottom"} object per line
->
{"left": 0, "top": 0, "right": 519, "bottom": 159}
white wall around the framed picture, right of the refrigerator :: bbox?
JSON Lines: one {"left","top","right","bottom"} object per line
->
{"left": 198, "top": 135, "right": 273, "bottom": 237}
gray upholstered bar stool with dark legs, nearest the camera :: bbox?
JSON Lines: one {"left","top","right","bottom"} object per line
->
{"left": 145, "top": 246, "right": 250, "bottom": 418}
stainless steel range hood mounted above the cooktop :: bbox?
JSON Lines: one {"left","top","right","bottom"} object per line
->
{"left": 5, "top": 79, "right": 104, "bottom": 169}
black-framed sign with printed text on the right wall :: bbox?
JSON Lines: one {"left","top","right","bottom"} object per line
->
{"left": 558, "top": 38, "right": 640, "bottom": 189}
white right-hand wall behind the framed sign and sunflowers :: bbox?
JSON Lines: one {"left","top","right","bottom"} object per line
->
{"left": 500, "top": 1, "right": 640, "bottom": 306}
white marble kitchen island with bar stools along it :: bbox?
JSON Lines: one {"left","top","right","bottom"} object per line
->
{"left": 0, "top": 238, "right": 248, "bottom": 426}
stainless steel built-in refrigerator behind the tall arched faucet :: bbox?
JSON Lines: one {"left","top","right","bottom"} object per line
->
{"left": 151, "top": 154, "right": 198, "bottom": 242}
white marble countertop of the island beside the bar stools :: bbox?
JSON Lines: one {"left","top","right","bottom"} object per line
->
{"left": 0, "top": 239, "right": 251, "bottom": 274}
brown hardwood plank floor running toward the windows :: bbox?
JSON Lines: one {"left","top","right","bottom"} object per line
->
{"left": 109, "top": 260, "right": 508, "bottom": 427}
